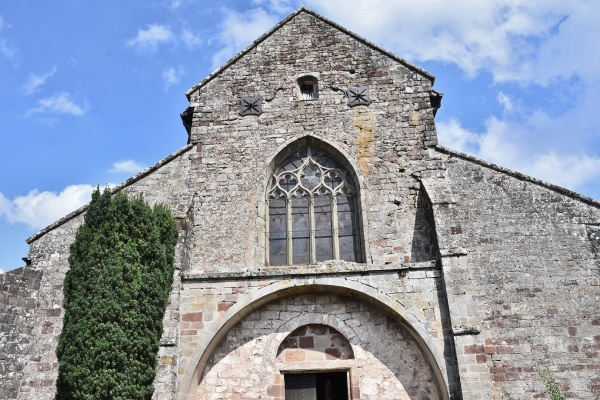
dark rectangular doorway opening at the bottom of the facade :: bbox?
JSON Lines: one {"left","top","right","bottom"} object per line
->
{"left": 285, "top": 371, "right": 348, "bottom": 400}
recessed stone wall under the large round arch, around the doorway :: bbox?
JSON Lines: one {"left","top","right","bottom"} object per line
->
{"left": 196, "top": 294, "right": 440, "bottom": 400}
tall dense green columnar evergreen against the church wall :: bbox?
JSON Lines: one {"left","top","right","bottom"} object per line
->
{"left": 57, "top": 189, "right": 177, "bottom": 400}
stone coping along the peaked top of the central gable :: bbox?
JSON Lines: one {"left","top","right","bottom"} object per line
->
{"left": 185, "top": 6, "right": 435, "bottom": 100}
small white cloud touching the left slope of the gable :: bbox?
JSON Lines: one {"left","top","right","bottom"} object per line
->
{"left": 212, "top": 8, "right": 279, "bottom": 69}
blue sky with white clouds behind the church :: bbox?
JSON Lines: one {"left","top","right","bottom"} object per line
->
{"left": 0, "top": 0, "right": 600, "bottom": 271}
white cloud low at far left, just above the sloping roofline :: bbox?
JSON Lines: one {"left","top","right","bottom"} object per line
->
{"left": 0, "top": 185, "right": 96, "bottom": 229}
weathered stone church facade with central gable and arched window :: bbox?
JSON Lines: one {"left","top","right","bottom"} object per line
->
{"left": 0, "top": 8, "right": 600, "bottom": 400}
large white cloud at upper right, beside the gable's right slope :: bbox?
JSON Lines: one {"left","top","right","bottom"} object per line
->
{"left": 305, "top": 0, "right": 600, "bottom": 83}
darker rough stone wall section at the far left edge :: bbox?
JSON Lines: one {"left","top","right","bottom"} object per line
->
{"left": 0, "top": 267, "right": 43, "bottom": 399}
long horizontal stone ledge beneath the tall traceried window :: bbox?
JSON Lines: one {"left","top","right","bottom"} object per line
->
{"left": 181, "top": 261, "right": 439, "bottom": 280}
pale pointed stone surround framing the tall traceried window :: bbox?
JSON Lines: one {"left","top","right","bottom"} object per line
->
{"left": 255, "top": 133, "right": 370, "bottom": 267}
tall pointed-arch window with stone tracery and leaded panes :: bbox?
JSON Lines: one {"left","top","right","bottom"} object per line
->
{"left": 266, "top": 147, "right": 361, "bottom": 266}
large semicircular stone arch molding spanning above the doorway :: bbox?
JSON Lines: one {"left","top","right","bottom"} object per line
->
{"left": 179, "top": 276, "right": 449, "bottom": 400}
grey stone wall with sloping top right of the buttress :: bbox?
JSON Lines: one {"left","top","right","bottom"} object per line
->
{"left": 425, "top": 151, "right": 600, "bottom": 399}
